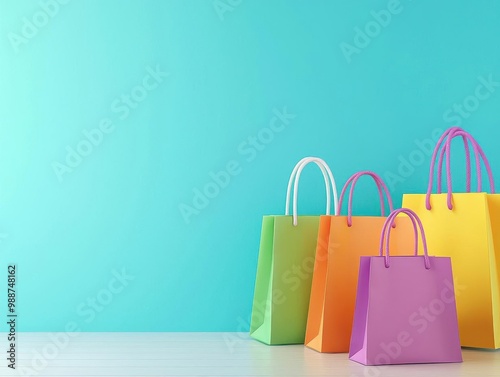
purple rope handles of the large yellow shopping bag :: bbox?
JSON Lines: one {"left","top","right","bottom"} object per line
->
{"left": 425, "top": 127, "right": 495, "bottom": 210}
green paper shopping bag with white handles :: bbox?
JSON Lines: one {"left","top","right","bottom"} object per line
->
{"left": 250, "top": 157, "right": 338, "bottom": 344}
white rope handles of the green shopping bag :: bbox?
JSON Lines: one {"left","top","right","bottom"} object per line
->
{"left": 285, "top": 157, "right": 338, "bottom": 226}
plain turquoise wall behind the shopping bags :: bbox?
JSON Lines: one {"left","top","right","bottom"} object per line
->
{"left": 0, "top": 0, "right": 500, "bottom": 331}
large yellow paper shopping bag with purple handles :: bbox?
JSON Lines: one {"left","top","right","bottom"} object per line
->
{"left": 403, "top": 127, "right": 500, "bottom": 349}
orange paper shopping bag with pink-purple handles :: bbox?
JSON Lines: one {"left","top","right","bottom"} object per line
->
{"left": 305, "top": 171, "right": 413, "bottom": 352}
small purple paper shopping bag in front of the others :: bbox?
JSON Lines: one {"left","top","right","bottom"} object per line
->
{"left": 349, "top": 209, "right": 462, "bottom": 365}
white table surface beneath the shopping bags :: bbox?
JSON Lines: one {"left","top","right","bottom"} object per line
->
{"left": 0, "top": 333, "right": 500, "bottom": 377}
